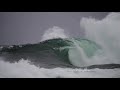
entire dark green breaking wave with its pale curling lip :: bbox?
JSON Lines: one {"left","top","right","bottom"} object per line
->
{"left": 0, "top": 38, "right": 118, "bottom": 68}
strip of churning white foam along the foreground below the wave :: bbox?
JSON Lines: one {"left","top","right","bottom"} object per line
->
{"left": 0, "top": 59, "right": 120, "bottom": 78}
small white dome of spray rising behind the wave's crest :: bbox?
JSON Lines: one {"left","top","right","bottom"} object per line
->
{"left": 41, "top": 26, "right": 68, "bottom": 41}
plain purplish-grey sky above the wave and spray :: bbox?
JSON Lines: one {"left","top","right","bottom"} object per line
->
{"left": 0, "top": 12, "right": 108, "bottom": 45}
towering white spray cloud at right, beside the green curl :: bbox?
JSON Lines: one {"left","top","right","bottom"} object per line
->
{"left": 80, "top": 13, "right": 120, "bottom": 64}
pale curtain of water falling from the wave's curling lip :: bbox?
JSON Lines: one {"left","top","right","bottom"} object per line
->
{"left": 68, "top": 38, "right": 88, "bottom": 67}
